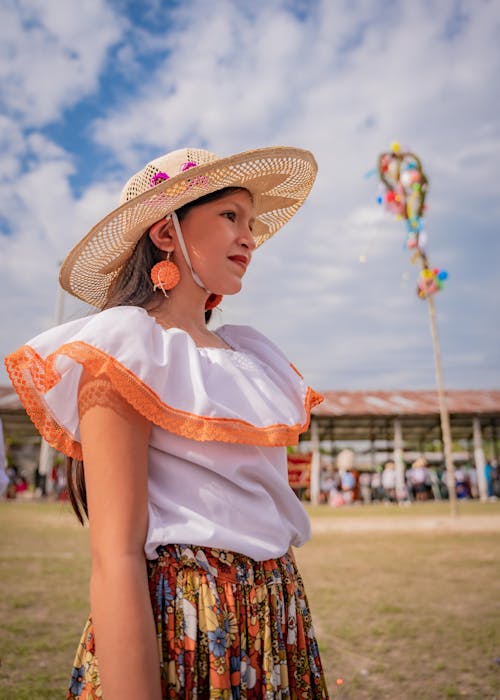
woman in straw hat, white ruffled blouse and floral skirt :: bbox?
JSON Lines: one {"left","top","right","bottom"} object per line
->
{"left": 6, "top": 148, "right": 327, "bottom": 700}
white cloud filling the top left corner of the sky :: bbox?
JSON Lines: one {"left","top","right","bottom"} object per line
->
{"left": 0, "top": 0, "right": 124, "bottom": 126}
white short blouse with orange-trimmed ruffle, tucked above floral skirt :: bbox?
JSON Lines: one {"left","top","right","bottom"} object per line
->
{"left": 5, "top": 306, "right": 321, "bottom": 560}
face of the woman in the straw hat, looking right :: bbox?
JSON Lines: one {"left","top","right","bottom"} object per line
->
{"left": 181, "top": 190, "right": 255, "bottom": 294}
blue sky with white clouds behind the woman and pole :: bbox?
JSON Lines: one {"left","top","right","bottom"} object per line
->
{"left": 0, "top": 0, "right": 500, "bottom": 390}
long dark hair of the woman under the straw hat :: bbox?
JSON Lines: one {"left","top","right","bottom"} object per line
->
{"left": 66, "top": 187, "right": 250, "bottom": 525}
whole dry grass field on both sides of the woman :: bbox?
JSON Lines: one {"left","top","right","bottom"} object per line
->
{"left": 0, "top": 501, "right": 500, "bottom": 700}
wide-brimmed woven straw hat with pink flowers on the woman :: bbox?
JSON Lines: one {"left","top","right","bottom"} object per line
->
{"left": 59, "top": 146, "right": 317, "bottom": 308}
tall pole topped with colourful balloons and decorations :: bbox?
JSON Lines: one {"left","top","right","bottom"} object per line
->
{"left": 377, "top": 143, "right": 457, "bottom": 516}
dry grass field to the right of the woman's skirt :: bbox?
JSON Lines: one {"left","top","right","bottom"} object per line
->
{"left": 297, "top": 504, "right": 500, "bottom": 700}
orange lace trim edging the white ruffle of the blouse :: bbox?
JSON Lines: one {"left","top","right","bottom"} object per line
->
{"left": 5, "top": 341, "right": 323, "bottom": 459}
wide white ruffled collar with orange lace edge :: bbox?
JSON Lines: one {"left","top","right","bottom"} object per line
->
{"left": 6, "top": 307, "right": 321, "bottom": 456}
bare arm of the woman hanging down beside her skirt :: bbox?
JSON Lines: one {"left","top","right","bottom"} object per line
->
{"left": 79, "top": 374, "right": 161, "bottom": 700}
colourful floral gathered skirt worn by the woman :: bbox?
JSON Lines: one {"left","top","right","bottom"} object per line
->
{"left": 67, "top": 545, "right": 328, "bottom": 700}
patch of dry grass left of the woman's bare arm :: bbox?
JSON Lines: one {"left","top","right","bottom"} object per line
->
{"left": 0, "top": 502, "right": 89, "bottom": 700}
